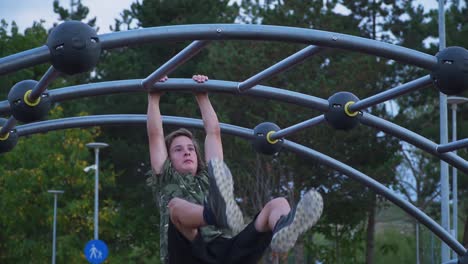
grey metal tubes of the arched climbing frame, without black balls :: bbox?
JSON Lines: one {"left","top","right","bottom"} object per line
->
{"left": 0, "top": 24, "right": 468, "bottom": 260}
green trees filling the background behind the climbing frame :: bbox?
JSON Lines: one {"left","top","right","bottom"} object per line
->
{"left": 0, "top": 0, "right": 468, "bottom": 263}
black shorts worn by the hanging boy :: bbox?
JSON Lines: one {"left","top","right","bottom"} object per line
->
{"left": 168, "top": 218, "right": 272, "bottom": 264}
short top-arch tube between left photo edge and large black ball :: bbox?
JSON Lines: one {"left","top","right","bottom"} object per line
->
{"left": 0, "top": 45, "right": 50, "bottom": 75}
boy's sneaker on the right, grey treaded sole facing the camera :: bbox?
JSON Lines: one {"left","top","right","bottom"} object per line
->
{"left": 270, "top": 190, "right": 323, "bottom": 253}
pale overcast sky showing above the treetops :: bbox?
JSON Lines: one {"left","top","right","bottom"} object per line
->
{"left": 0, "top": 0, "right": 446, "bottom": 34}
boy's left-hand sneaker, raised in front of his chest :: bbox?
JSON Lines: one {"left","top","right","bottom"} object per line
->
{"left": 203, "top": 159, "right": 244, "bottom": 233}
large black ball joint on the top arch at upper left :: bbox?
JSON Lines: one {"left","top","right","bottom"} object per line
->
{"left": 47, "top": 21, "right": 101, "bottom": 74}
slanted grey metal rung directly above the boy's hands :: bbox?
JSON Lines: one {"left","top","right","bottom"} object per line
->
{"left": 141, "top": 40, "right": 210, "bottom": 89}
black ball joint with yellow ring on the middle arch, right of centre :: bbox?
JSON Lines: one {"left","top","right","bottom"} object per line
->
{"left": 325, "top": 92, "right": 361, "bottom": 130}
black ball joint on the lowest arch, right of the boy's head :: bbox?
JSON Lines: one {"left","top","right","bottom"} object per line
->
{"left": 252, "top": 122, "right": 283, "bottom": 155}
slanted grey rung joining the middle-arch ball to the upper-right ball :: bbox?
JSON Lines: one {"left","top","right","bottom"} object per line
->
{"left": 349, "top": 75, "right": 432, "bottom": 112}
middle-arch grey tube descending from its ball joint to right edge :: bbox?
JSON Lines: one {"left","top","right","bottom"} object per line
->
{"left": 361, "top": 112, "right": 468, "bottom": 174}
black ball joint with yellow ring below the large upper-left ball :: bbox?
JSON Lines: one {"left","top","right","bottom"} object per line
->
{"left": 8, "top": 80, "right": 51, "bottom": 123}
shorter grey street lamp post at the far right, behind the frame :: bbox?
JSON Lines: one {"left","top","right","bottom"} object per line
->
{"left": 447, "top": 96, "right": 468, "bottom": 256}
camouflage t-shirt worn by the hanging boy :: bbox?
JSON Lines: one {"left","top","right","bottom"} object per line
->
{"left": 147, "top": 160, "right": 232, "bottom": 263}
